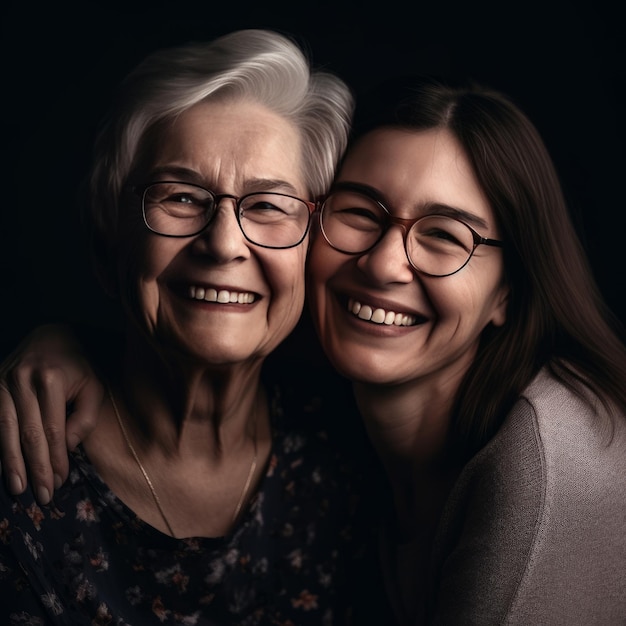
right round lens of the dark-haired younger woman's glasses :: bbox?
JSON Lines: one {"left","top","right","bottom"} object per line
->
{"left": 406, "top": 215, "right": 474, "bottom": 276}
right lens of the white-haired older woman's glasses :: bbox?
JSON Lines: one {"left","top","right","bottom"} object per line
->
{"left": 239, "top": 193, "right": 311, "bottom": 248}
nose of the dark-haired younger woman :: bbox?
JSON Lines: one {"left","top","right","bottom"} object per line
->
{"left": 357, "top": 224, "right": 415, "bottom": 284}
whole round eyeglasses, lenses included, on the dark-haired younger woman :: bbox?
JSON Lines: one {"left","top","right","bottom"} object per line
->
{"left": 320, "top": 184, "right": 503, "bottom": 276}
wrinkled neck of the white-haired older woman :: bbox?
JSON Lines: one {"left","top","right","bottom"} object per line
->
{"left": 112, "top": 330, "right": 264, "bottom": 456}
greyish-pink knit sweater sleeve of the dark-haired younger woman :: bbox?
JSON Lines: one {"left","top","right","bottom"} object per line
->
{"left": 431, "top": 375, "right": 626, "bottom": 625}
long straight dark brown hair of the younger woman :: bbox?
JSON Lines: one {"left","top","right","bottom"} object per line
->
{"left": 354, "top": 78, "right": 626, "bottom": 457}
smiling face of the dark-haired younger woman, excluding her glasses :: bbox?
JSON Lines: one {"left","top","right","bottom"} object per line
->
{"left": 308, "top": 129, "right": 508, "bottom": 391}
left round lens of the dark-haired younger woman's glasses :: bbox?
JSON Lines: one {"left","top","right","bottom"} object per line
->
{"left": 320, "top": 190, "right": 387, "bottom": 253}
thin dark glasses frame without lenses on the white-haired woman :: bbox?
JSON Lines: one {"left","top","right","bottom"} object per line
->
{"left": 132, "top": 180, "right": 317, "bottom": 250}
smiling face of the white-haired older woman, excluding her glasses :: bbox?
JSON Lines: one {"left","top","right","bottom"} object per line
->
{"left": 114, "top": 101, "right": 308, "bottom": 365}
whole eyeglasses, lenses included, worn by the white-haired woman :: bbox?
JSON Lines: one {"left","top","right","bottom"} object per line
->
{"left": 135, "top": 181, "right": 315, "bottom": 248}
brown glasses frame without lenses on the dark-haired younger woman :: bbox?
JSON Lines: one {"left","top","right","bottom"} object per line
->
{"left": 319, "top": 183, "right": 504, "bottom": 278}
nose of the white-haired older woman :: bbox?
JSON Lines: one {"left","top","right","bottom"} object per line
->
{"left": 193, "top": 194, "right": 250, "bottom": 263}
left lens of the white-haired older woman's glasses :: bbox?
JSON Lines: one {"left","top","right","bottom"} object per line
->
{"left": 143, "top": 182, "right": 215, "bottom": 237}
